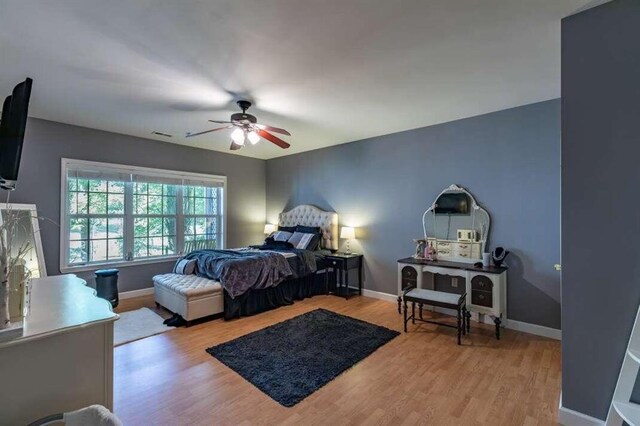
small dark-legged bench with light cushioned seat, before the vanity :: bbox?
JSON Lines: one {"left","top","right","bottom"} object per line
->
{"left": 402, "top": 288, "right": 471, "bottom": 344}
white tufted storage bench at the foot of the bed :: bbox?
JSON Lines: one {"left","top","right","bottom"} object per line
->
{"left": 153, "top": 274, "right": 224, "bottom": 322}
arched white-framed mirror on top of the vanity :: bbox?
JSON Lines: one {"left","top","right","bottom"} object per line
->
{"left": 422, "top": 185, "right": 491, "bottom": 263}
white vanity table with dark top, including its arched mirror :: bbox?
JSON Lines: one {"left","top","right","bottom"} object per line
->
{"left": 398, "top": 185, "right": 507, "bottom": 339}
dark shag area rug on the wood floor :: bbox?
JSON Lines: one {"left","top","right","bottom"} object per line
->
{"left": 207, "top": 309, "right": 400, "bottom": 407}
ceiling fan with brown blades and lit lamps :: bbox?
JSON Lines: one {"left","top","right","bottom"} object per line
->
{"left": 187, "top": 100, "right": 291, "bottom": 150}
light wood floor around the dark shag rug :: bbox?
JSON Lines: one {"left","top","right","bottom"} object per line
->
{"left": 115, "top": 296, "right": 560, "bottom": 426}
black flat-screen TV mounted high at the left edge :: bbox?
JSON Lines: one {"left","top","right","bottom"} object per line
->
{"left": 0, "top": 78, "right": 33, "bottom": 190}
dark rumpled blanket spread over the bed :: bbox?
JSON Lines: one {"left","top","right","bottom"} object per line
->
{"left": 185, "top": 246, "right": 316, "bottom": 298}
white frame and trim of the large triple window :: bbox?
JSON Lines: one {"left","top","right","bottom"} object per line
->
{"left": 60, "top": 158, "right": 227, "bottom": 273}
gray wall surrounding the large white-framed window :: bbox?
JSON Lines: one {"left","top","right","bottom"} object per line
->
{"left": 11, "top": 118, "right": 266, "bottom": 291}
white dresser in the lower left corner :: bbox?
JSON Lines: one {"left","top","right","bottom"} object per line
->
{"left": 0, "top": 275, "right": 118, "bottom": 425}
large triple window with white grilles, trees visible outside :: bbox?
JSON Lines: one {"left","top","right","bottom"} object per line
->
{"left": 60, "top": 159, "right": 226, "bottom": 271}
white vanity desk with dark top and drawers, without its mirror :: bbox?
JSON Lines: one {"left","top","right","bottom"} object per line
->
{"left": 398, "top": 257, "right": 507, "bottom": 339}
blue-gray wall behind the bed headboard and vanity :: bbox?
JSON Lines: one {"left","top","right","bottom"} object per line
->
{"left": 267, "top": 100, "right": 560, "bottom": 328}
